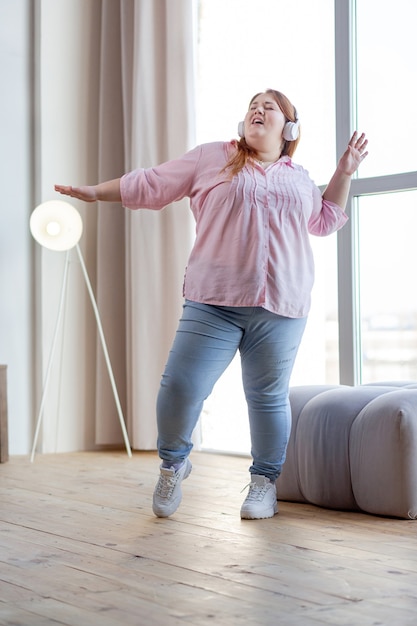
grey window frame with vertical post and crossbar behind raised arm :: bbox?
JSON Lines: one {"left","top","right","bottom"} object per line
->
{"left": 335, "top": 0, "right": 417, "bottom": 385}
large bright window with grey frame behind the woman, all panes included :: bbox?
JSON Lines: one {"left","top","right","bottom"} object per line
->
{"left": 197, "top": 0, "right": 417, "bottom": 452}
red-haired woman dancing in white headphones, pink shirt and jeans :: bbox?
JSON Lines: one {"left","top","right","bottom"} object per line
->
{"left": 55, "top": 90, "right": 367, "bottom": 519}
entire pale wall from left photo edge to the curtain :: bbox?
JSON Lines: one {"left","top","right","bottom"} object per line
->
{"left": 0, "top": 0, "right": 95, "bottom": 455}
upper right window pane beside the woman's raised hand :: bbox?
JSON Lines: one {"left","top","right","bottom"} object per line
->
{"left": 356, "top": 0, "right": 417, "bottom": 177}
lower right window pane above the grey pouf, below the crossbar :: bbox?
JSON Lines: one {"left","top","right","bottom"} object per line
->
{"left": 357, "top": 191, "right": 417, "bottom": 383}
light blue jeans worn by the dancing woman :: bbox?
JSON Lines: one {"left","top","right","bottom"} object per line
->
{"left": 157, "top": 301, "right": 306, "bottom": 480}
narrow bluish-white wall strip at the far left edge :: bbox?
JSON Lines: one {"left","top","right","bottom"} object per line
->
{"left": 0, "top": 0, "right": 33, "bottom": 454}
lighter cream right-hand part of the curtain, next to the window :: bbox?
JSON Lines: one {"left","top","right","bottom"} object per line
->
{"left": 127, "top": 0, "right": 194, "bottom": 449}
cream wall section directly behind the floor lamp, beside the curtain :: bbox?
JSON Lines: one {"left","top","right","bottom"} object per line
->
{"left": 36, "top": 0, "right": 97, "bottom": 453}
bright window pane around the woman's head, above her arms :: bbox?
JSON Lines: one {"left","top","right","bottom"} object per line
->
{"left": 197, "top": 0, "right": 336, "bottom": 184}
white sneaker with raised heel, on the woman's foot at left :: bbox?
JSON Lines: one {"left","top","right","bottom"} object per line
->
{"left": 152, "top": 459, "right": 192, "bottom": 517}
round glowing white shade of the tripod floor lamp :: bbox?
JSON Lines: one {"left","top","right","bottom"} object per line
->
{"left": 29, "top": 200, "right": 83, "bottom": 250}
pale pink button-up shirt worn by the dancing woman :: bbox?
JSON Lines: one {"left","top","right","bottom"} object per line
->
{"left": 120, "top": 142, "right": 347, "bottom": 317}
